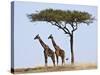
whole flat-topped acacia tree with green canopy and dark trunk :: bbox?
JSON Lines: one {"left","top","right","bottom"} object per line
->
{"left": 28, "top": 9, "right": 94, "bottom": 64}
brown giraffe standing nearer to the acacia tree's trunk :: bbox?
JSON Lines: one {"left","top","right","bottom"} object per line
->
{"left": 48, "top": 34, "right": 65, "bottom": 65}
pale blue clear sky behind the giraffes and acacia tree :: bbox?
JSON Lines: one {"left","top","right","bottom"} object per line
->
{"left": 14, "top": 1, "right": 97, "bottom": 68}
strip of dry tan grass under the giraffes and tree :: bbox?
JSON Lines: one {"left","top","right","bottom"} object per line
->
{"left": 15, "top": 64, "right": 97, "bottom": 73}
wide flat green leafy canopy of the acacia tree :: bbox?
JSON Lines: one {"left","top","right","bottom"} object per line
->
{"left": 28, "top": 9, "right": 94, "bottom": 24}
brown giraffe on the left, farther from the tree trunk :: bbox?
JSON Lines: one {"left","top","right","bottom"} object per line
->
{"left": 34, "top": 34, "right": 55, "bottom": 67}
